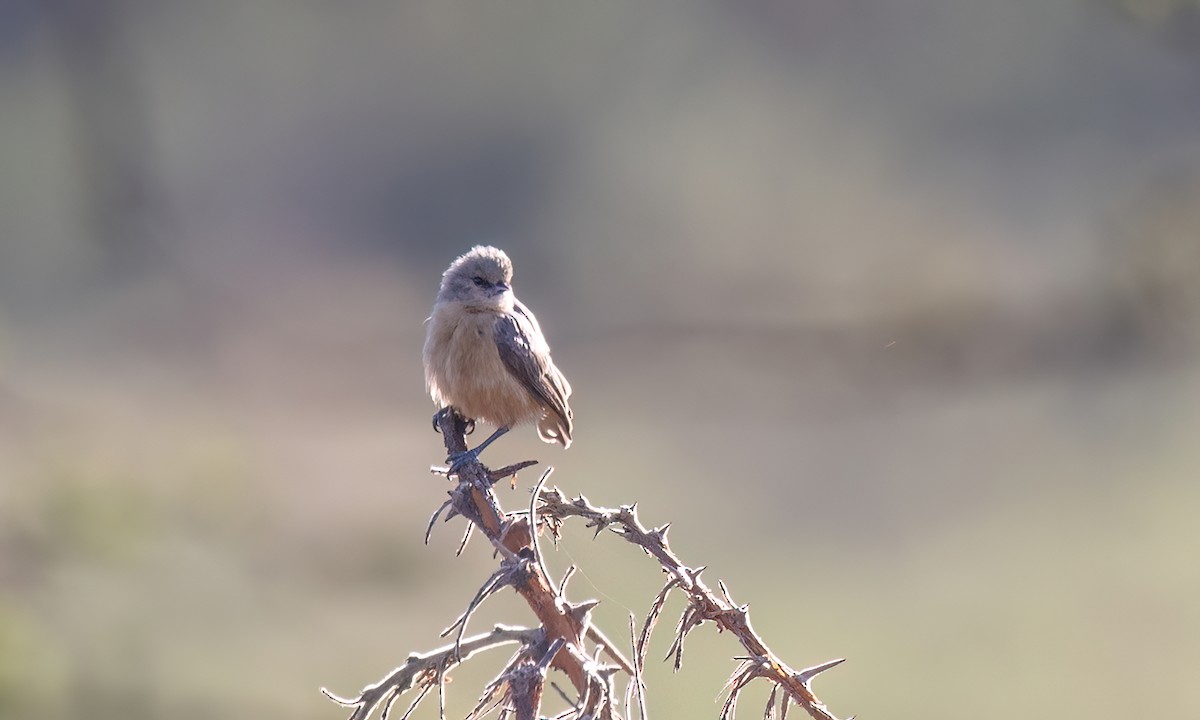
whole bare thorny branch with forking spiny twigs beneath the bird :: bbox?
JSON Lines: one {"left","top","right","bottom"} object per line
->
{"left": 322, "top": 413, "right": 852, "bottom": 720}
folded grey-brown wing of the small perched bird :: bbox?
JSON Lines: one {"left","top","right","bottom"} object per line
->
{"left": 496, "top": 302, "right": 571, "bottom": 432}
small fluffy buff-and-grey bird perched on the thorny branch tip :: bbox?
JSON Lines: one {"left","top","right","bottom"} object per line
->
{"left": 424, "top": 246, "right": 571, "bottom": 473}
